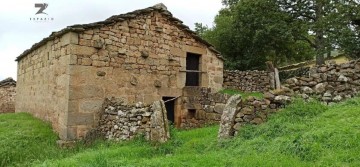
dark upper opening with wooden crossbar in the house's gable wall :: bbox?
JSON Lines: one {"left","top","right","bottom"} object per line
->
{"left": 185, "top": 53, "right": 201, "bottom": 86}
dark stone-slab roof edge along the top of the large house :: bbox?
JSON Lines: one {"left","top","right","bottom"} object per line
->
{"left": 16, "top": 3, "right": 224, "bottom": 61}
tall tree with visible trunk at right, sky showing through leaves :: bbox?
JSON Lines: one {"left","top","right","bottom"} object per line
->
{"left": 277, "top": 0, "right": 359, "bottom": 65}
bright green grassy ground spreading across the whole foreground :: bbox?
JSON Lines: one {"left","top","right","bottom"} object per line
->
{"left": 0, "top": 98, "right": 360, "bottom": 167}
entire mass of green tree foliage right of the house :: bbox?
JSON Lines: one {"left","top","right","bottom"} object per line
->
{"left": 200, "top": 0, "right": 360, "bottom": 70}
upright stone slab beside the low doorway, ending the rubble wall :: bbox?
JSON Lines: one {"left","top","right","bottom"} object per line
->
{"left": 150, "top": 101, "right": 170, "bottom": 143}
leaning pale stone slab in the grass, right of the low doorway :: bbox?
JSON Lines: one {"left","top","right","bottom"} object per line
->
{"left": 218, "top": 95, "right": 241, "bottom": 139}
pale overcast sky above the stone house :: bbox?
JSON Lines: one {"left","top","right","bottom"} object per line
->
{"left": 0, "top": 0, "right": 222, "bottom": 80}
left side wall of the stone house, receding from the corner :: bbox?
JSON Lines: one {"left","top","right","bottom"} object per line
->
{"left": 15, "top": 33, "right": 73, "bottom": 138}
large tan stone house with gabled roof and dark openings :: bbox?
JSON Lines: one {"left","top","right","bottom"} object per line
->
{"left": 16, "top": 4, "right": 223, "bottom": 140}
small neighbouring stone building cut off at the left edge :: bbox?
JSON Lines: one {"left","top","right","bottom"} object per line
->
{"left": 0, "top": 78, "right": 16, "bottom": 113}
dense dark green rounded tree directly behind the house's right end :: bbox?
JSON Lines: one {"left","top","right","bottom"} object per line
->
{"left": 197, "top": 0, "right": 312, "bottom": 70}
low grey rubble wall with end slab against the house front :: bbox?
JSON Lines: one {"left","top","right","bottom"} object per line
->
{"left": 97, "top": 98, "right": 170, "bottom": 142}
